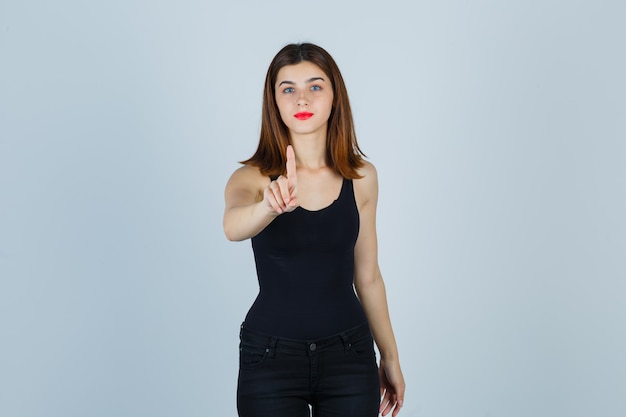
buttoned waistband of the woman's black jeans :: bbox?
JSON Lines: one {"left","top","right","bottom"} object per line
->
{"left": 239, "top": 322, "right": 372, "bottom": 356}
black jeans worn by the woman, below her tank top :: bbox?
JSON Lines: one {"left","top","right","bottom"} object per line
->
{"left": 237, "top": 323, "right": 380, "bottom": 417}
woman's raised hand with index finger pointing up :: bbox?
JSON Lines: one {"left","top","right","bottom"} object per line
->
{"left": 263, "top": 145, "right": 298, "bottom": 214}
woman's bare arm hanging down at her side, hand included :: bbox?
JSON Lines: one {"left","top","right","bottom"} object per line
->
{"left": 353, "top": 162, "right": 405, "bottom": 417}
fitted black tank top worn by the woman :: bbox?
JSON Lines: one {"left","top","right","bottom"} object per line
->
{"left": 245, "top": 179, "right": 366, "bottom": 340}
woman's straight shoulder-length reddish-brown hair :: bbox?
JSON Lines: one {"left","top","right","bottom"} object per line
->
{"left": 241, "top": 43, "right": 365, "bottom": 179}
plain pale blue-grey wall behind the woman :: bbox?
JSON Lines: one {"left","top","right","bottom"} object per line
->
{"left": 0, "top": 0, "right": 626, "bottom": 417}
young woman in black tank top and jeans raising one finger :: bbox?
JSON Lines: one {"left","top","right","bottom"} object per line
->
{"left": 224, "top": 43, "right": 405, "bottom": 417}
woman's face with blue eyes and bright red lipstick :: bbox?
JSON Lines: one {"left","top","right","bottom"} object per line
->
{"left": 274, "top": 61, "right": 333, "bottom": 137}
